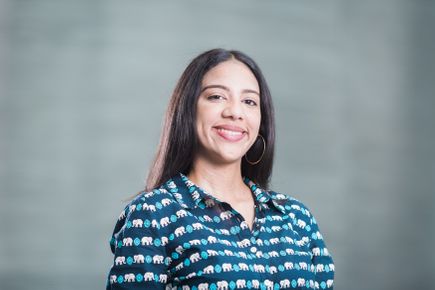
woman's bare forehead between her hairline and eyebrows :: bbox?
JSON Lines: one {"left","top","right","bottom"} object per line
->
{"left": 202, "top": 59, "right": 259, "bottom": 91}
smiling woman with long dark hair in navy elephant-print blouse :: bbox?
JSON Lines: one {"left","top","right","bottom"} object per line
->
{"left": 107, "top": 49, "right": 334, "bottom": 289}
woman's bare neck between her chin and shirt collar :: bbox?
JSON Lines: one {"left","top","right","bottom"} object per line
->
{"left": 188, "top": 159, "right": 247, "bottom": 201}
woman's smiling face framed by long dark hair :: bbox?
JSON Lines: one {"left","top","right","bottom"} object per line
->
{"left": 196, "top": 60, "right": 261, "bottom": 164}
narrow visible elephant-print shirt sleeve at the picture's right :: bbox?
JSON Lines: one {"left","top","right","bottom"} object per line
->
{"left": 310, "top": 215, "right": 335, "bottom": 289}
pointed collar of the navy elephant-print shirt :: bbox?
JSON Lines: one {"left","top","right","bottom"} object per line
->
{"left": 165, "top": 173, "right": 290, "bottom": 214}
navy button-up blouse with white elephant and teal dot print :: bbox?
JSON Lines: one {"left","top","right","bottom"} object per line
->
{"left": 107, "top": 174, "right": 334, "bottom": 290}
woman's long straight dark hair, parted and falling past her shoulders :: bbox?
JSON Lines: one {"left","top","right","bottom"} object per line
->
{"left": 146, "top": 48, "right": 275, "bottom": 190}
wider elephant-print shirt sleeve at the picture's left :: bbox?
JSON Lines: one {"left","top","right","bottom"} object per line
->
{"left": 106, "top": 199, "right": 170, "bottom": 290}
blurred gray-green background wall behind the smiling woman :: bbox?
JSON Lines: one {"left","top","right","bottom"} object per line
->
{"left": 0, "top": 0, "right": 435, "bottom": 290}
